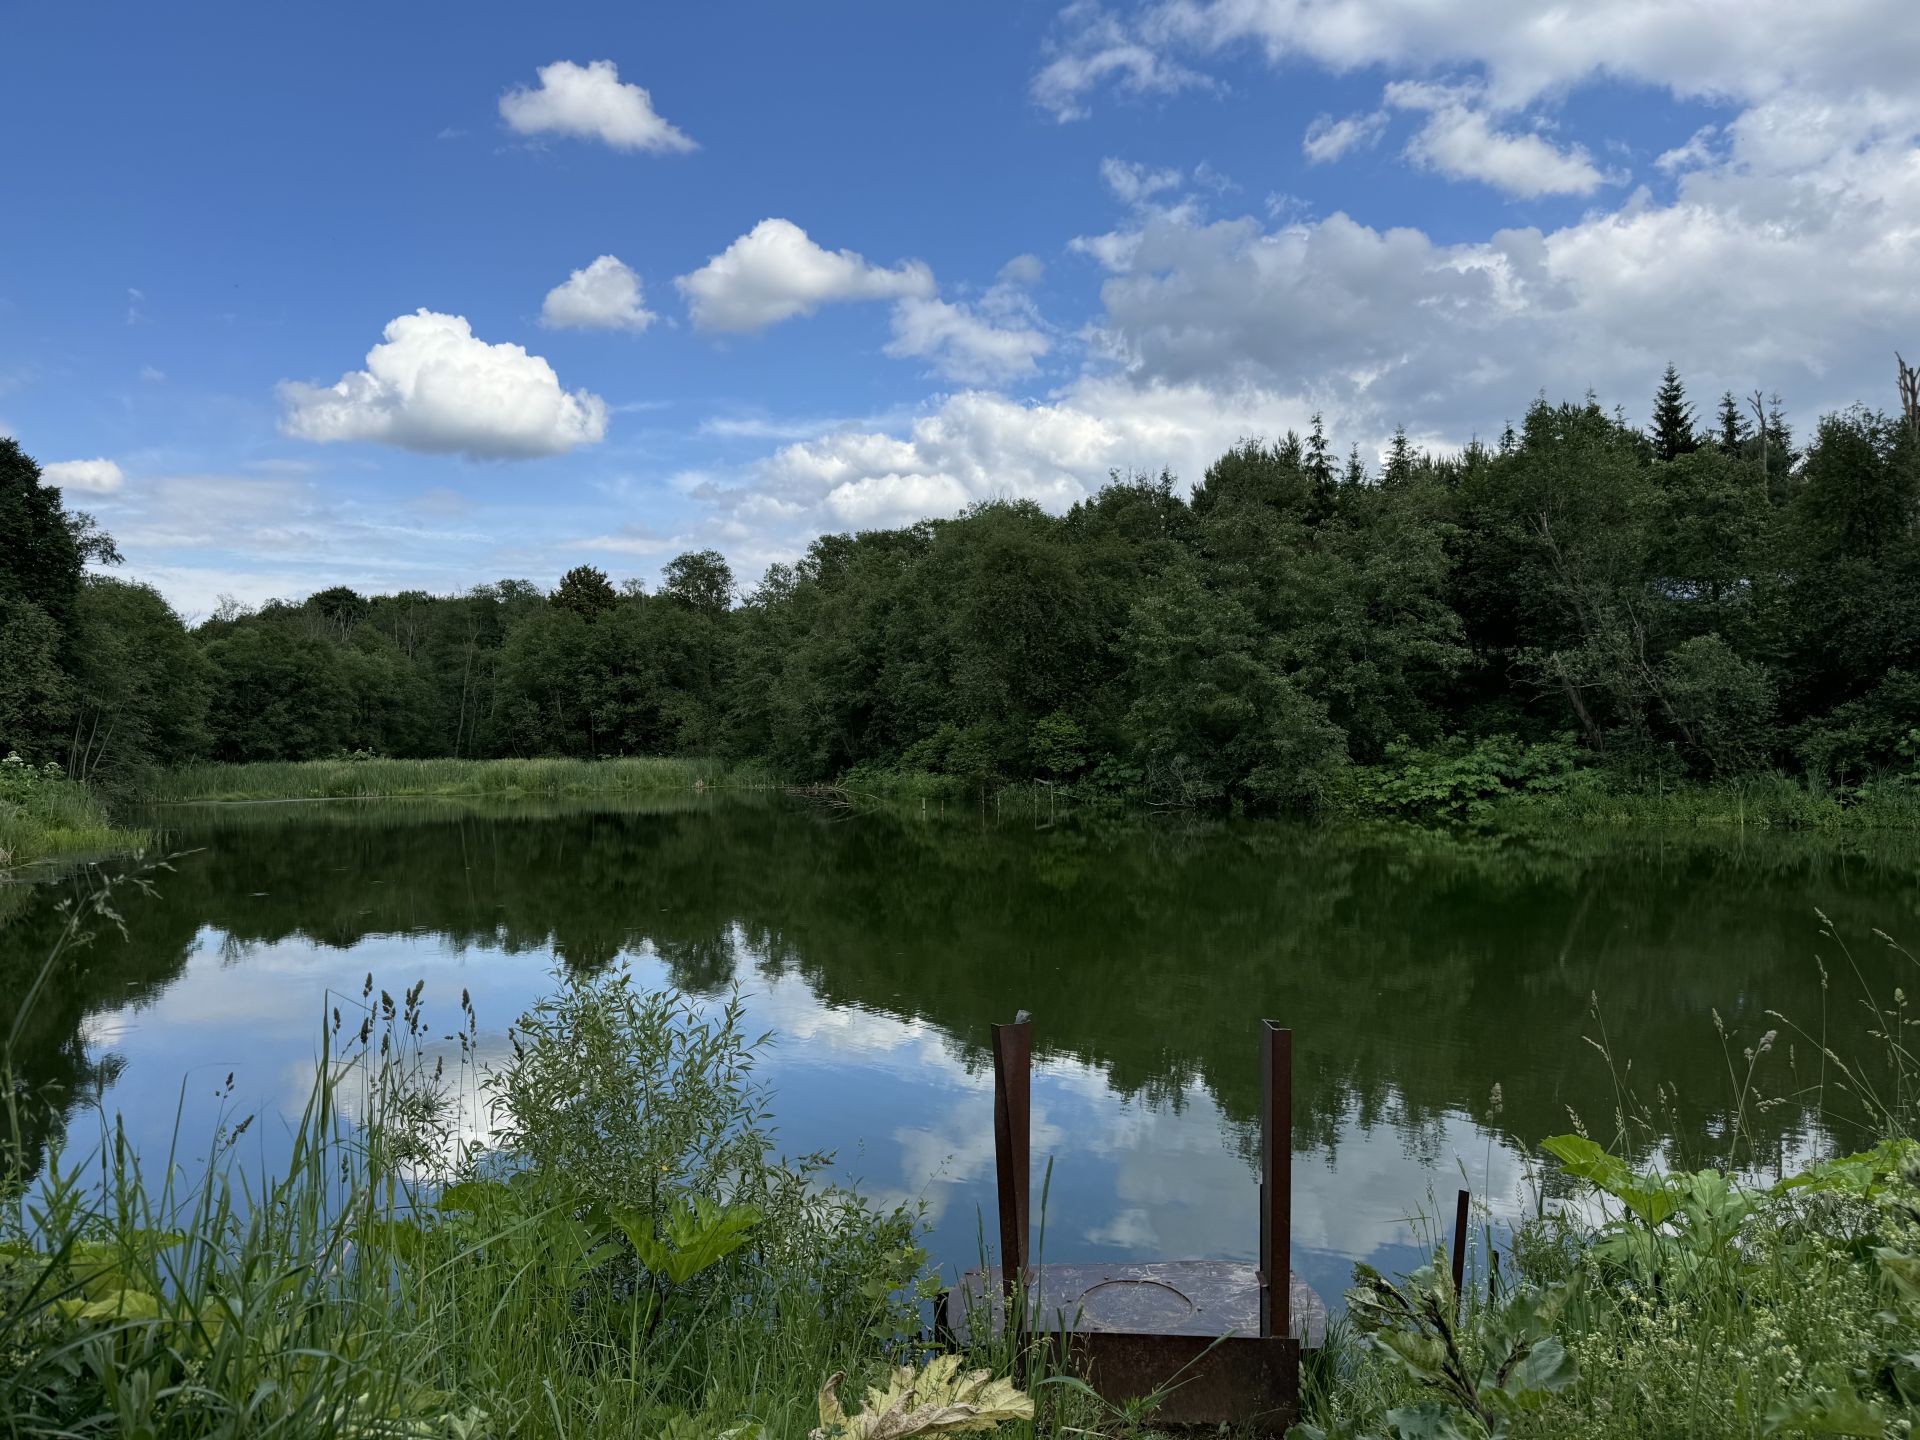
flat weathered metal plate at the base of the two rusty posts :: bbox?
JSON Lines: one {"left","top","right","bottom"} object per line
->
{"left": 954, "top": 1260, "right": 1327, "bottom": 1350}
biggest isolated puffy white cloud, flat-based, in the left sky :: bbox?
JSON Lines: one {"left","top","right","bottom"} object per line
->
{"left": 280, "top": 309, "right": 607, "bottom": 459}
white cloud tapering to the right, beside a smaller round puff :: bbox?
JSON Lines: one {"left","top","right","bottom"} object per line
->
{"left": 674, "top": 219, "right": 933, "bottom": 330}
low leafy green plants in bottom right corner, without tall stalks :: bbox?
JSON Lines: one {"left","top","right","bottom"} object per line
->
{"left": 1296, "top": 1135, "right": 1920, "bottom": 1440}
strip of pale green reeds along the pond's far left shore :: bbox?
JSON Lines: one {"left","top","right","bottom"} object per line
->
{"left": 142, "top": 758, "right": 766, "bottom": 804}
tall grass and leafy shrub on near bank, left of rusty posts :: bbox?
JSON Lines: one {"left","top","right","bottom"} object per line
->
{"left": 0, "top": 875, "right": 1023, "bottom": 1440}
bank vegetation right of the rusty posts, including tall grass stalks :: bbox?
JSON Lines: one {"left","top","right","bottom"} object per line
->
{"left": 1296, "top": 933, "right": 1920, "bottom": 1440}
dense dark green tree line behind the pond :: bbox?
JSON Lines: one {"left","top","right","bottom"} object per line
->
{"left": 0, "top": 369, "right": 1920, "bottom": 808}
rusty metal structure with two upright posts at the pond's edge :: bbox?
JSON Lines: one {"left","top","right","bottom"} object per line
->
{"left": 943, "top": 1016, "right": 1327, "bottom": 1436}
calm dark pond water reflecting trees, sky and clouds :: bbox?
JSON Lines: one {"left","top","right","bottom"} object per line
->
{"left": 0, "top": 797, "right": 1920, "bottom": 1294}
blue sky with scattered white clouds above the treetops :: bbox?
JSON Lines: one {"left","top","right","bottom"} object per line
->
{"left": 0, "top": 0, "right": 1920, "bottom": 612}
